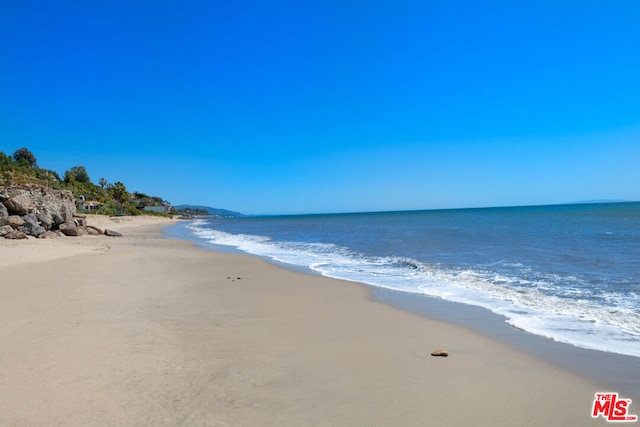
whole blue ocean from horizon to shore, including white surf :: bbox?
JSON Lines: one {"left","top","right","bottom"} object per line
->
{"left": 180, "top": 203, "right": 640, "bottom": 357}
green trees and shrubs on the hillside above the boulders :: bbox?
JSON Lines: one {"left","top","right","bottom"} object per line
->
{"left": 0, "top": 148, "right": 170, "bottom": 216}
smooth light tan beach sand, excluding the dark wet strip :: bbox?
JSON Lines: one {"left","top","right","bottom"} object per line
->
{"left": 0, "top": 217, "right": 624, "bottom": 426}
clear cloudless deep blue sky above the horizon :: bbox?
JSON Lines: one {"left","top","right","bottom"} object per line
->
{"left": 0, "top": 0, "right": 640, "bottom": 214}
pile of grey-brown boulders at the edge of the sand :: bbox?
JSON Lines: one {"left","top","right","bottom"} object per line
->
{"left": 0, "top": 185, "right": 119, "bottom": 239}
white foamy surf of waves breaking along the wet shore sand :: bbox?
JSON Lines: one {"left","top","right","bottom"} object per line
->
{"left": 189, "top": 221, "right": 640, "bottom": 357}
